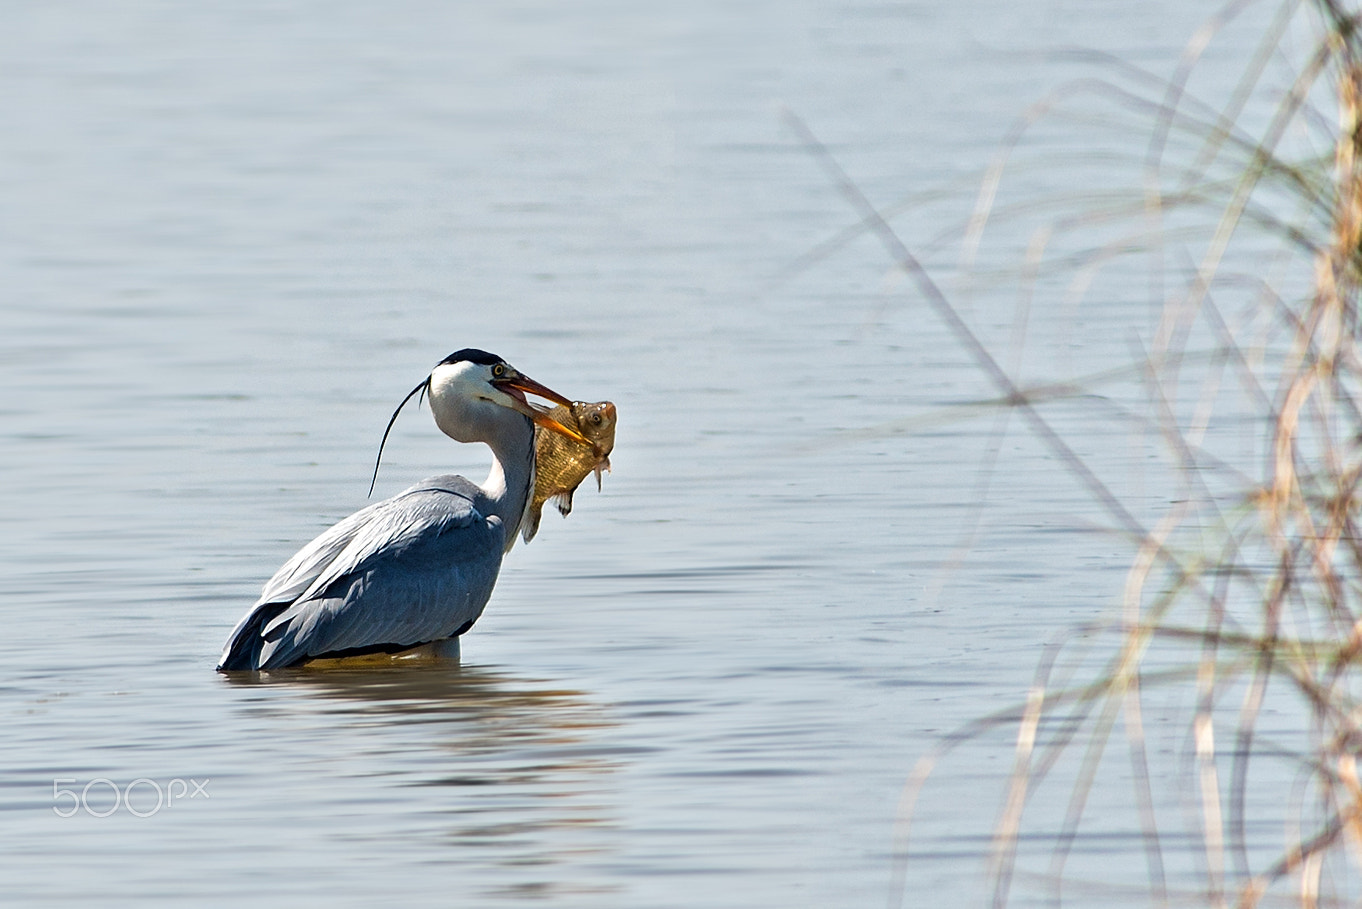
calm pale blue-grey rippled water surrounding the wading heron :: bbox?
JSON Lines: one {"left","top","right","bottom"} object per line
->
{"left": 0, "top": 0, "right": 1291, "bottom": 906}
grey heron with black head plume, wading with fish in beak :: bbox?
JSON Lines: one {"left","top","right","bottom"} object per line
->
{"left": 218, "top": 348, "right": 590, "bottom": 672}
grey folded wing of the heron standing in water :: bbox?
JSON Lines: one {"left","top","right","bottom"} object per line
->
{"left": 222, "top": 481, "right": 505, "bottom": 669}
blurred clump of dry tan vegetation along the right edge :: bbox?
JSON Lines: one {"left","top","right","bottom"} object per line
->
{"left": 789, "top": 0, "right": 1362, "bottom": 906}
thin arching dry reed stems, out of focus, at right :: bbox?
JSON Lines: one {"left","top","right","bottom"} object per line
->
{"left": 786, "top": 0, "right": 1362, "bottom": 908}
